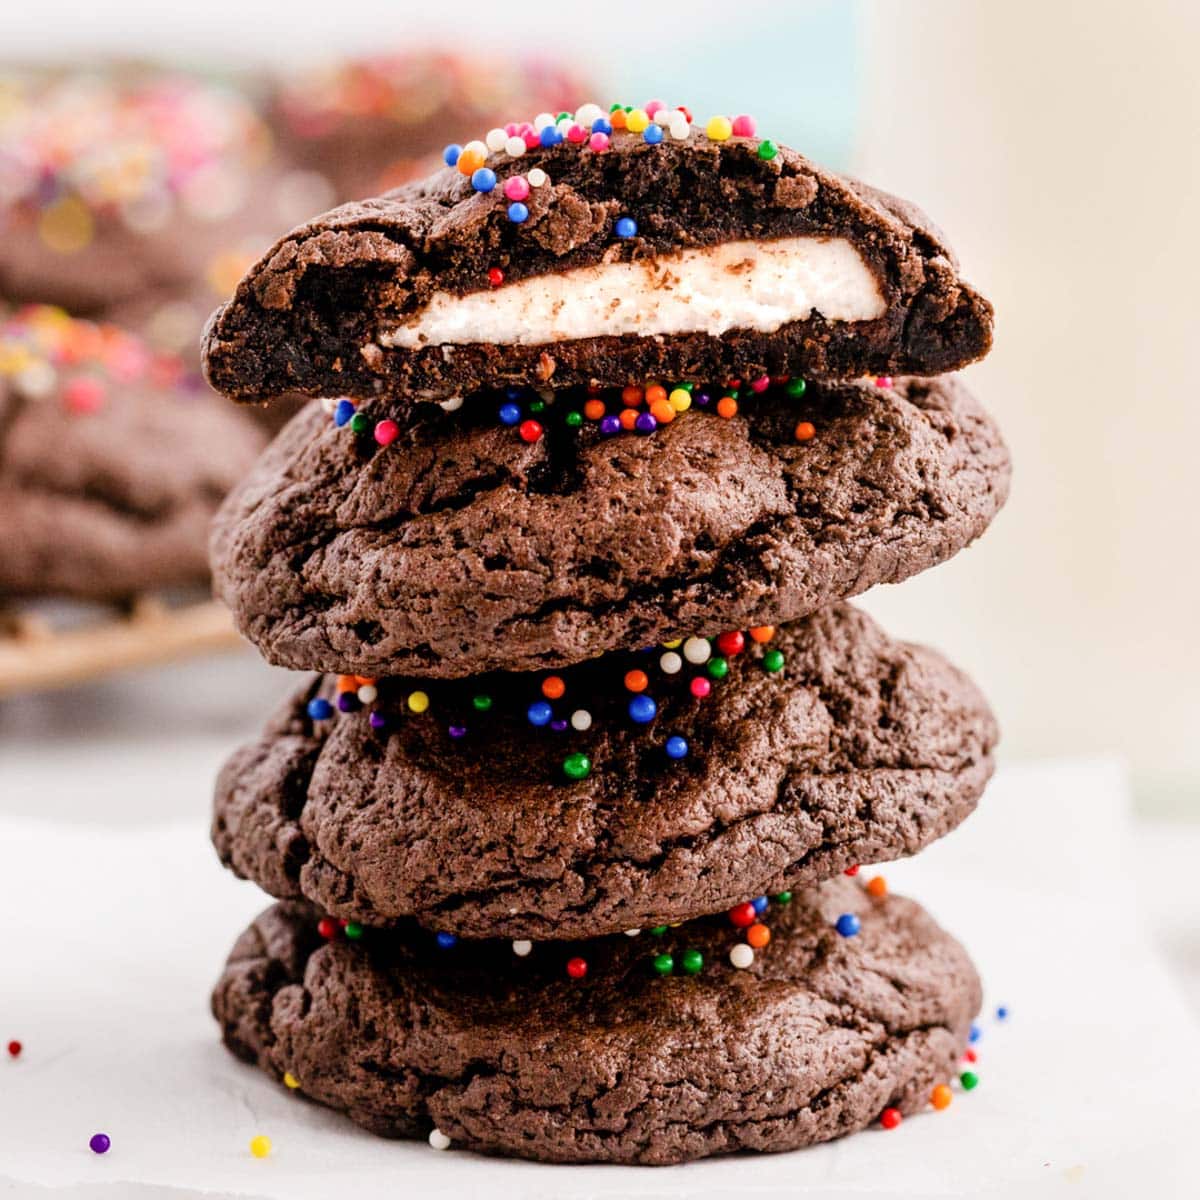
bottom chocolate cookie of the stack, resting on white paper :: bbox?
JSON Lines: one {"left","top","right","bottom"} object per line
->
{"left": 212, "top": 880, "right": 980, "bottom": 1164}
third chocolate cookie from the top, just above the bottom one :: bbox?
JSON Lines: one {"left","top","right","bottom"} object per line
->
{"left": 214, "top": 606, "right": 996, "bottom": 938}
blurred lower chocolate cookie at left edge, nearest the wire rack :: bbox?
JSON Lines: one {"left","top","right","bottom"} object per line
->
{"left": 0, "top": 306, "right": 263, "bottom": 599}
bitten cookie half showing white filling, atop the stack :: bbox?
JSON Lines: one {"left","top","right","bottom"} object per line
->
{"left": 205, "top": 104, "right": 992, "bottom": 402}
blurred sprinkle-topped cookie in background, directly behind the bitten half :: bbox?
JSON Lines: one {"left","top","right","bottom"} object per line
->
{"left": 265, "top": 49, "right": 595, "bottom": 200}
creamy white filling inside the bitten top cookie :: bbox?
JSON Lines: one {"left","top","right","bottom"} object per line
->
{"left": 379, "top": 238, "right": 887, "bottom": 349}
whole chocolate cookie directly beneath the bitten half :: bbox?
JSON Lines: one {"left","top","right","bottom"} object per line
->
{"left": 212, "top": 369, "right": 1009, "bottom": 677}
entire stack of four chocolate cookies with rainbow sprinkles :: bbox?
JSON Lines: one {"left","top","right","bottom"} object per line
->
{"left": 205, "top": 103, "right": 1009, "bottom": 1163}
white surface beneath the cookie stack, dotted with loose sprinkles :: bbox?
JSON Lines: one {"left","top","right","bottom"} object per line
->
{"left": 0, "top": 656, "right": 1200, "bottom": 1200}
